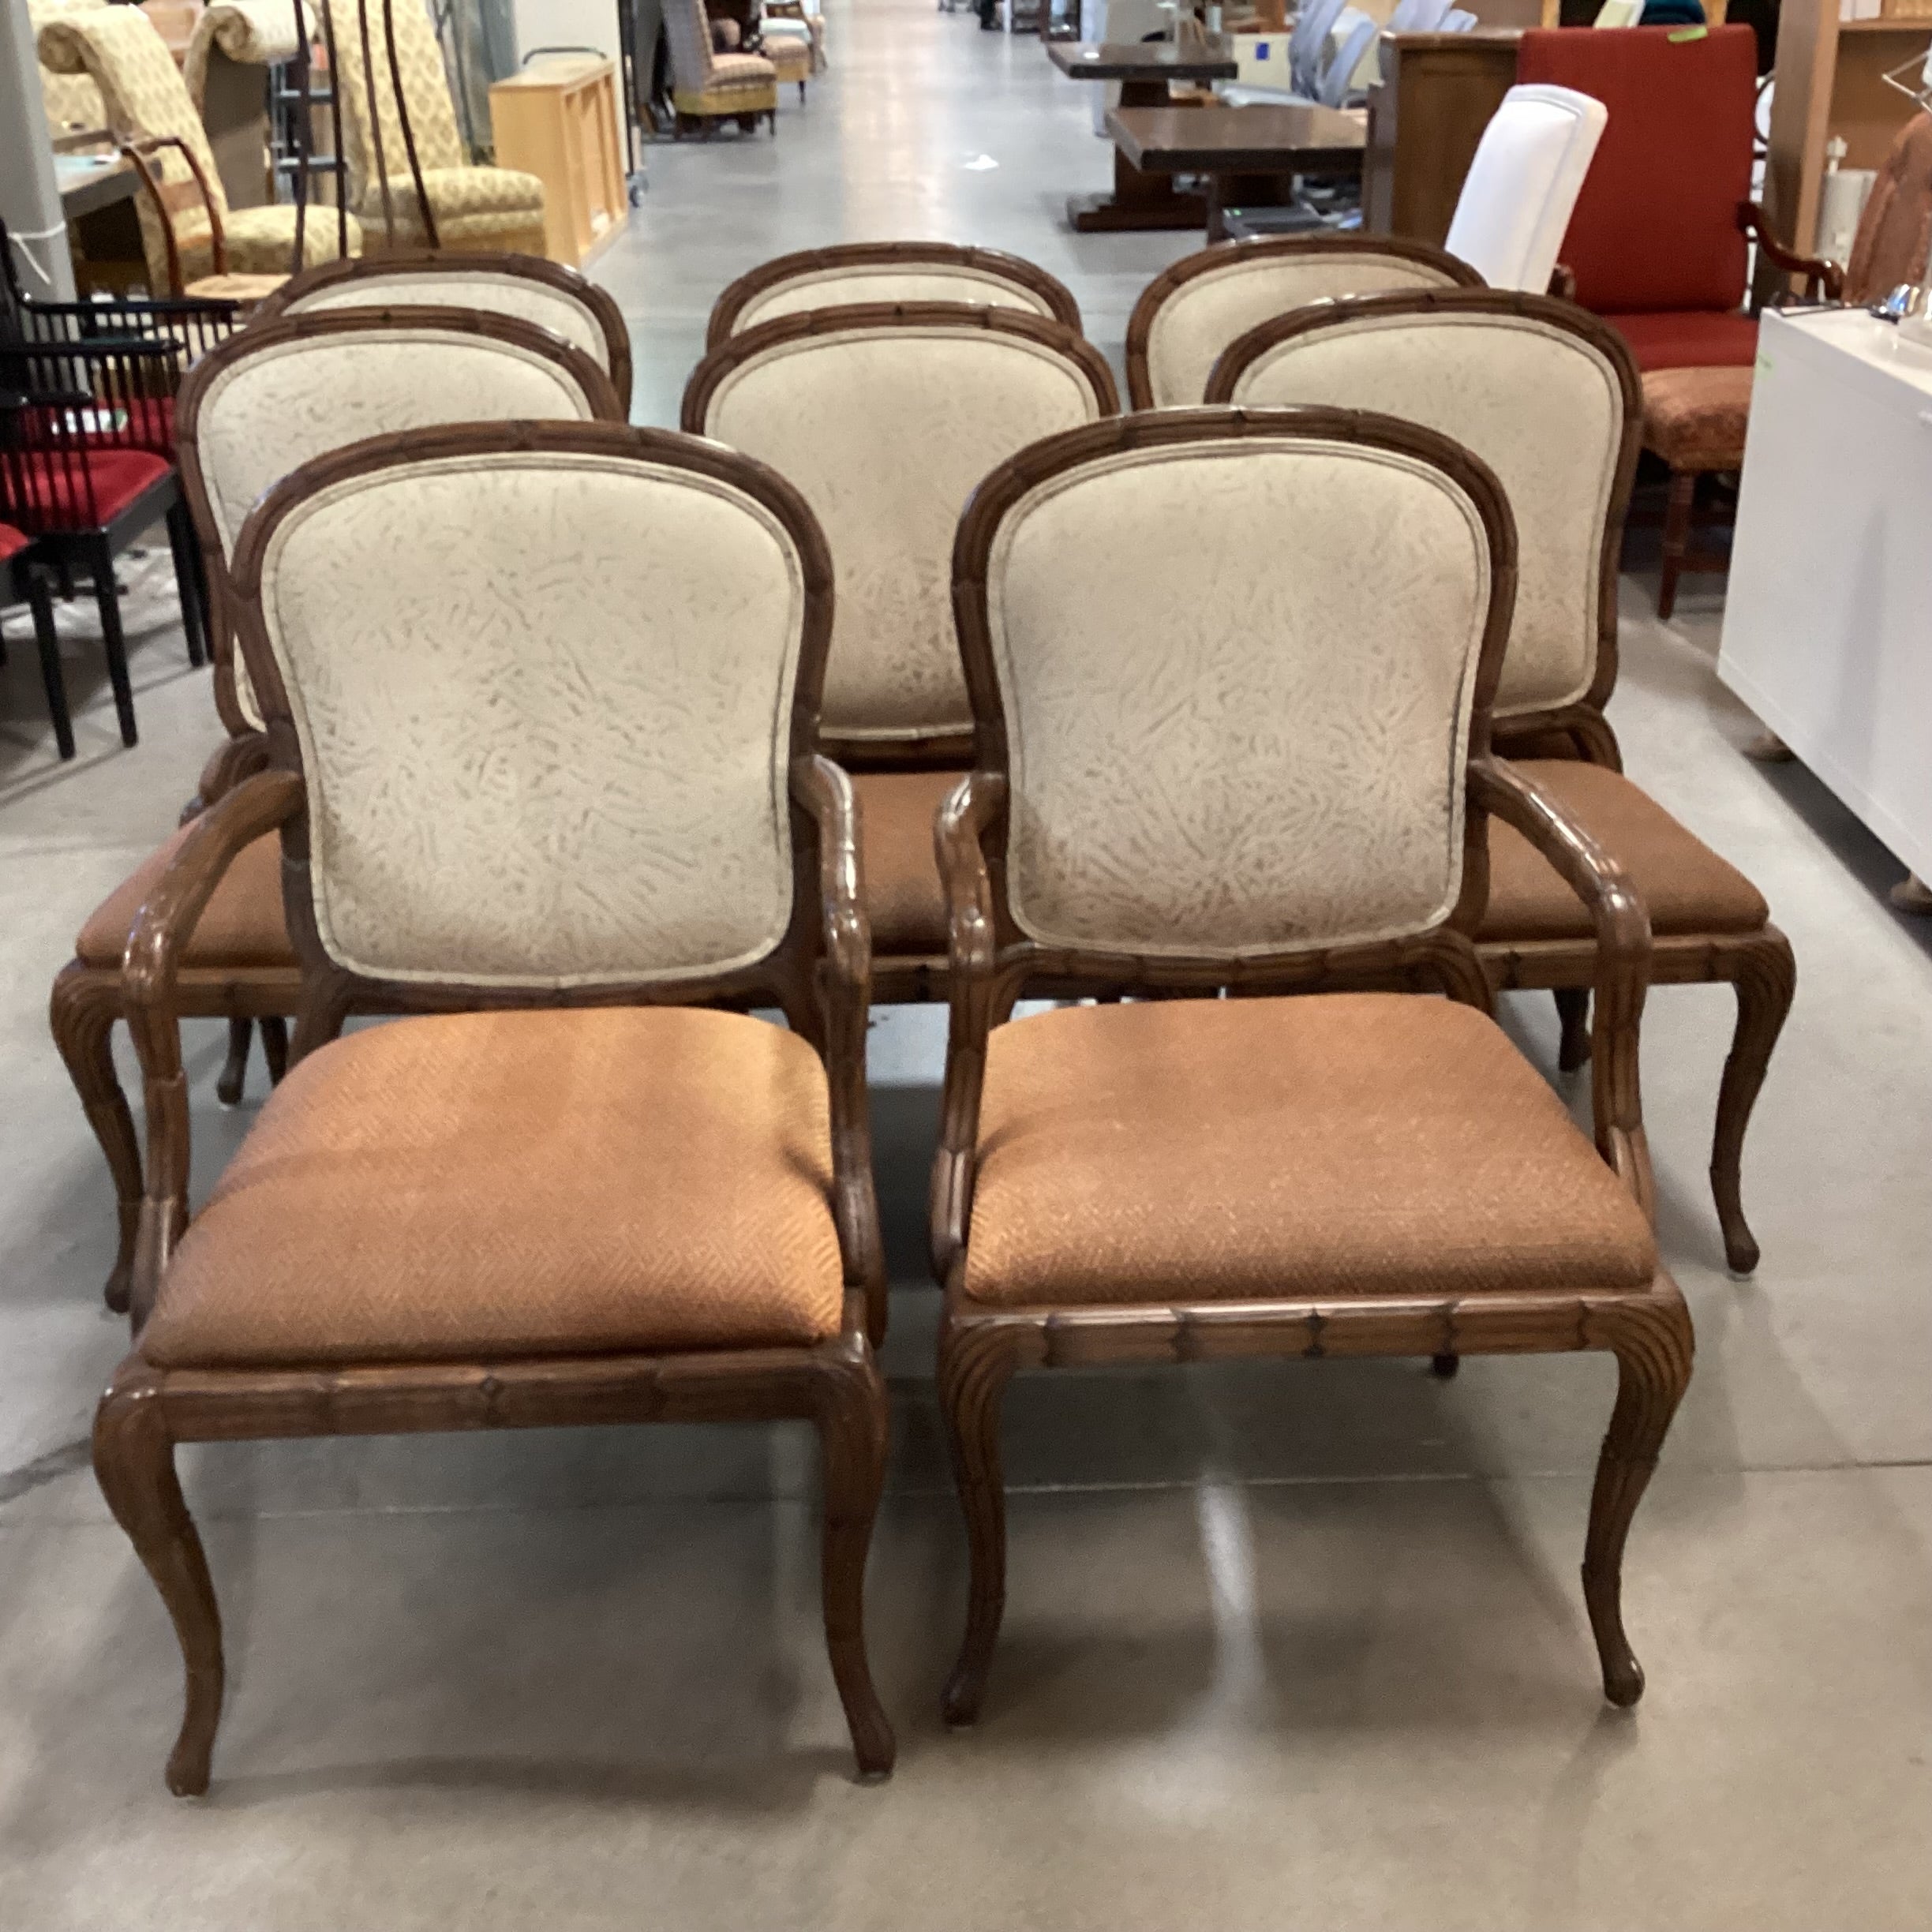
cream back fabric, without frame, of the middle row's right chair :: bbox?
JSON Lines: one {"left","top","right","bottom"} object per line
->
{"left": 1234, "top": 315, "right": 1623, "bottom": 715}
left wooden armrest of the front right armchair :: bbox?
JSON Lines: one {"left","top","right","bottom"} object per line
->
{"left": 927, "top": 771, "right": 1006, "bottom": 1281}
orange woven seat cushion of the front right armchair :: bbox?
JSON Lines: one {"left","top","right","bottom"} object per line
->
{"left": 966, "top": 993, "right": 1657, "bottom": 1306}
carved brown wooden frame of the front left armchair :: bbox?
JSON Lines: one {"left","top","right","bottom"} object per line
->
{"left": 95, "top": 423, "right": 894, "bottom": 1793}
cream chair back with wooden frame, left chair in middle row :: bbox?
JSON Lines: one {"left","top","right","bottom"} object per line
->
{"left": 176, "top": 309, "right": 624, "bottom": 732}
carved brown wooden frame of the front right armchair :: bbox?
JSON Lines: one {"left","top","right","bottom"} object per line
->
{"left": 931, "top": 410, "right": 1692, "bottom": 1724}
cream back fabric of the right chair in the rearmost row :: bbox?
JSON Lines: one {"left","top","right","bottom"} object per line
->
{"left": 1148, "top": 245, "right": 1457, "bottom": 410}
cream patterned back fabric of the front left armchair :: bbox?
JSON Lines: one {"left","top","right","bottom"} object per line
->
{"left": 251, "top": 454, "right": 803, "bottom": 987}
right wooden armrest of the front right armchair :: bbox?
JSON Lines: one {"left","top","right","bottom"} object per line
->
{"left": 1468, "top": 758, "right": 1656, "bottom": 1219}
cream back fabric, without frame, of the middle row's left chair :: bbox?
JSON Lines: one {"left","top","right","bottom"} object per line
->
{"left": 195, "top": 328, "right": 593, "bottom": 724}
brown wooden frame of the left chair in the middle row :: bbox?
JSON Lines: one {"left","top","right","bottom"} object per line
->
{"left": 48, "top": 313, "right": 626, "bottom": 1314}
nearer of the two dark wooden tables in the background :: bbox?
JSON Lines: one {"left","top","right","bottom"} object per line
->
{"left": 1107, "top": 107, "right": 1368, "bottom": 242}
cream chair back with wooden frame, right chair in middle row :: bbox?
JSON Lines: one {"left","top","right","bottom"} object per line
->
{"left": 1209, "top": 290, "right": 1642, "bottom": 721}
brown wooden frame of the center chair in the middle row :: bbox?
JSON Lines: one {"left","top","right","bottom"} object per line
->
{"left": 682, "top": 305, "right": 1121, "bottom": 1005}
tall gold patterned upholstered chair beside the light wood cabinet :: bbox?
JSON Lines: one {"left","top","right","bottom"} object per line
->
{"left": 313, "top": 0, "right": 543, "bottom": 255}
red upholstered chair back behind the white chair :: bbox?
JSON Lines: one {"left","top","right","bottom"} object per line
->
{"left": 1517, "top": 27, "right": 1758, "bottom": 318}
